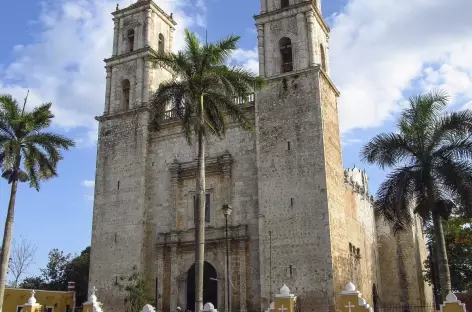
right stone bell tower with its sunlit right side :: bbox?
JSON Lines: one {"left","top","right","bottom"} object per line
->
{"left": 255, "top": 0, "right": 344, "bottom": 311}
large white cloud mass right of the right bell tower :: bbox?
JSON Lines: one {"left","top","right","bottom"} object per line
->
{"left": 330, "top": 0, "right": 472, "bottom": 133}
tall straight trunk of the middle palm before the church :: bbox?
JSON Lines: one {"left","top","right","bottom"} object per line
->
{"left": 195, "top": 95, "right": 206, "bottom": 312}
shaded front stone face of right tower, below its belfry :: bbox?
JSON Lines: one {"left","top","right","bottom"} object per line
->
{"left": 256, "top": 69, "right": 336, "bottom": 308}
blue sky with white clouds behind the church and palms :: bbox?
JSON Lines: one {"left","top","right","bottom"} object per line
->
{"left": 0, "top": 0, "right": 472, "bottom": 280}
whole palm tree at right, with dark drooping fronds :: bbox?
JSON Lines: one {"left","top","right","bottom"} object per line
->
{"left": 361, "top": 91, "right": 472, "bottom": 297}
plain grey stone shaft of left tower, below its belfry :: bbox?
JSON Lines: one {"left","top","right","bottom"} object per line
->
{"left": 90, "top": 111, "right": 148, "bottom": 311}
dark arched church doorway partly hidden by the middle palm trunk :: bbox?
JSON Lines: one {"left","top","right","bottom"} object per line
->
{"left": 187, "top": 261, "right": 218, "bottom": 311}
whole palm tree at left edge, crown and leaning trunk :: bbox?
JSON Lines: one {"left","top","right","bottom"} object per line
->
{"left": 0, "top": 95, "right": 75, "bottom": 312}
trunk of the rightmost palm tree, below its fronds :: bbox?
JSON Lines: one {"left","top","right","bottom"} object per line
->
{"left": 433, "top": 212, "right": 451, "bottom": 302}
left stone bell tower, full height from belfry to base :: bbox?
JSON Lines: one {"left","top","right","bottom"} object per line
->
{"left": 90, "top": 0, "right": 176, "bottom": 311}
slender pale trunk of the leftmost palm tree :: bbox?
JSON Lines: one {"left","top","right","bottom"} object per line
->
{"left": 0, "top": 179, "right": 18, "bottom": 312}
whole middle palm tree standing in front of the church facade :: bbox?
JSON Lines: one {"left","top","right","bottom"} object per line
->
{"left": 150, "top": 30, "right": 262, "bottom": 312}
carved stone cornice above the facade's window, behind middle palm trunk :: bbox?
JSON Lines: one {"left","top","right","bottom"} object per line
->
{"left": 170, "top": 151, "right": 233, "bottom": 180}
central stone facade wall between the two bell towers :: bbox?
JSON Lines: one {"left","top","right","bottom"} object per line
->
{"left": 146, "top": 106, "right": 259, "bottom": 311}
